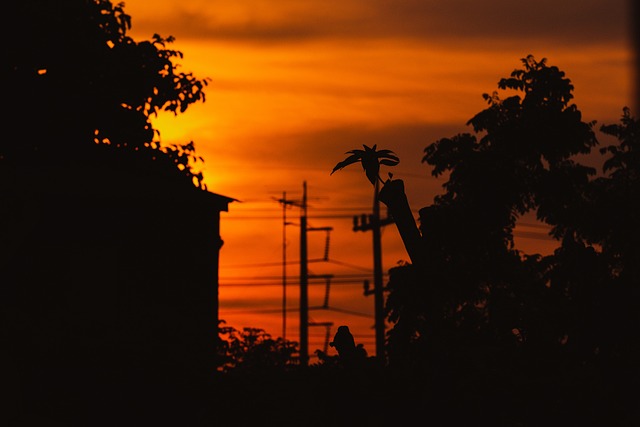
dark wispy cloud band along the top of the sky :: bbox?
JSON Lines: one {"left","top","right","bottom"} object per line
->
{"left": 127, "top": 0, "right": 631, "bottom": 46}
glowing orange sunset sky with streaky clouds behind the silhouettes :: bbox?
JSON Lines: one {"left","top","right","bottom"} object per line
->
{"left": 125, "top": 0, "right": 637, "bottom": 356}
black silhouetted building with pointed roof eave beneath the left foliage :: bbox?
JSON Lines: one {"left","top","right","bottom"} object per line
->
{"left": 0, "top": 154, "right": 234, "bottom": 422}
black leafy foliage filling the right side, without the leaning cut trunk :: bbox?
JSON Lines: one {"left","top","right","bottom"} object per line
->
{"left": 386, "top": 56, "right": 640, "bottom": 382}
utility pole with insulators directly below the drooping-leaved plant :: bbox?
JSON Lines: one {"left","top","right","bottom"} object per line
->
{"left": 353, "top": 181, "right": 393, "bottom": 363}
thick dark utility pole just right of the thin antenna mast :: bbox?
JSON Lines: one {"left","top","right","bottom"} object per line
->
{"left": 300, "top": 181, "right": 309, "bottom": 366}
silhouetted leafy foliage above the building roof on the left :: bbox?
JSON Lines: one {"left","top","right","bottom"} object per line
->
{"left": 5, "top": 0, "right": 208, "bottom": 188}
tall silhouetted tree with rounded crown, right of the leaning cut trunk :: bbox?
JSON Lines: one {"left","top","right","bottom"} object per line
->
{"left": 378, "top": 56, "right": 597, "bottom": 374}
